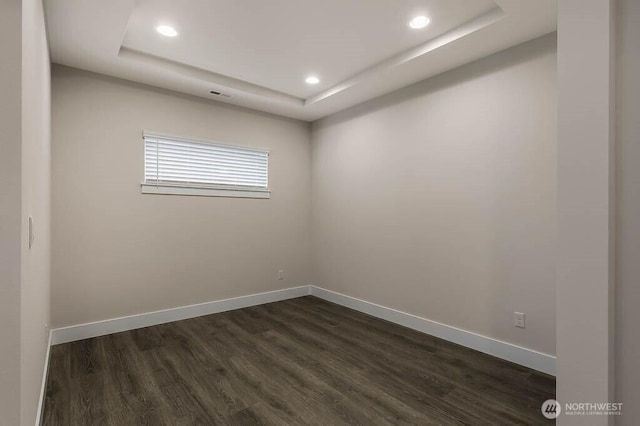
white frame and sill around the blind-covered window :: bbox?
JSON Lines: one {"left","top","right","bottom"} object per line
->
{"left": 140, "top": 131, "right": 271, "bottom": 199}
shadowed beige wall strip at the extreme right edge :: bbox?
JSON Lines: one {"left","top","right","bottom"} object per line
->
{"left": 615, "top": 0, "right": 640, "bottom": 425}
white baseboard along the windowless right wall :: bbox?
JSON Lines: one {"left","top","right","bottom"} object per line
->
{"left": 310, "top": 285, "right": 556, "bottom": 376}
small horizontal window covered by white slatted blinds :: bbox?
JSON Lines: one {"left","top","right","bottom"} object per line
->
{"left": 142, "top": 133, "right": 270, "bottom": 198}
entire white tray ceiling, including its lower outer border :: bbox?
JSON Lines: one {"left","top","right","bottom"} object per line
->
{"left": 45, "top": 0, "right": 556, "bottom": 121}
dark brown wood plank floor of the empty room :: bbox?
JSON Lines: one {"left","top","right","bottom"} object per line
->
{"left": 44, "top": 296, "right": 555, "bottom": 426}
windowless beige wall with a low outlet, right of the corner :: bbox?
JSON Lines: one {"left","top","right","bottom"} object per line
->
{"left": 312, "top": 35, "right": 556, "bottom": 354}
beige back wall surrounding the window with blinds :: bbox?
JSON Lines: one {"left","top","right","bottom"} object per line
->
{"left": 52, "top": 66, "right": 310, "bottom": 327}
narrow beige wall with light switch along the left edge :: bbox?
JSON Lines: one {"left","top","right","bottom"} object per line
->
{"left": 0, "top": 0, "right": 50, "bottom": 426}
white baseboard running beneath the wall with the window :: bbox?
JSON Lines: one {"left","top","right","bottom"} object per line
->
{"left": 51, "top": 286, "right": 310, "bottom": 345}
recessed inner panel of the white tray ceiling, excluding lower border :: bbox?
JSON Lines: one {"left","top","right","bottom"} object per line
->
{"left": 123, "top": 0, "right": 495, "bottom": 98}
